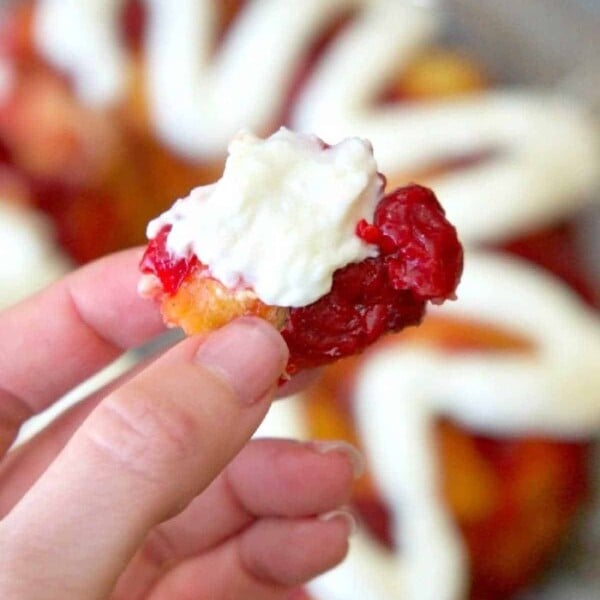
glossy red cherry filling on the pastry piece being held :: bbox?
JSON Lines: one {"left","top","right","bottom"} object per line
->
{"left": 140, "top": 185, "right": 463, "bottom": 374}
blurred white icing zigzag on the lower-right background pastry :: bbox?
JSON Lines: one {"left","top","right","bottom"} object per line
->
{"left": 261, "top": 252, "right": 600, "bottom": 600}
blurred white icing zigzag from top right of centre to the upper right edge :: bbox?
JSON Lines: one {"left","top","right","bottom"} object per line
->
{"left": 293, "top": 2, "right": 600, "bottom": 243}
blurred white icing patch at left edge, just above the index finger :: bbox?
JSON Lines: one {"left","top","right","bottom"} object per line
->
{"left": 0, "top": 198, "right": 68, "bottom": 309}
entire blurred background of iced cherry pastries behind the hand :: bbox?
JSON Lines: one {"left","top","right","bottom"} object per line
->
{"left": 0, "top": 0, "right": 600, "bottom": 600}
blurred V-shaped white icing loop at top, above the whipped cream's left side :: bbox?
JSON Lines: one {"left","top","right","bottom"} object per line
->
{"left": 147, "top": 0, "right": 357, "bottom": 158}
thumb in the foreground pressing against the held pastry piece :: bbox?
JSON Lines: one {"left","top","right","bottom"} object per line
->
{"left": 0, "top": 318, "right": 287, "bottom": 599}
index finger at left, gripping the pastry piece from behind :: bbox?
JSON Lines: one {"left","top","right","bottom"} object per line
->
{"left": 0, "top": 249, "right": 164, "bottom": 426}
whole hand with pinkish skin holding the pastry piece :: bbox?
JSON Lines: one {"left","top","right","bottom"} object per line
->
{"left": 0, "top": 251, "right": 357, "bottom": 600}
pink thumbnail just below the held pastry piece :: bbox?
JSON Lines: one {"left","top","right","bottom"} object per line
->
{"left": 195, "top": 317, "right": 288, "bottom": 404}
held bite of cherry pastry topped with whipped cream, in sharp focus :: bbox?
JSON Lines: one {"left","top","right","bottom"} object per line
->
{"left": 140, "top": 129, "right": 462, "bottom": 374}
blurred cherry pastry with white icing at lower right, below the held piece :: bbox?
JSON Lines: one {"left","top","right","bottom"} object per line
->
{"left": 262, "top": 252, "right": 600, "bottom": 600}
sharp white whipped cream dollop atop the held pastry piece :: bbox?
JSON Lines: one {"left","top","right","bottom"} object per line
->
{"left": 147, "top": 128, "right": 383, "bottom": 306}
